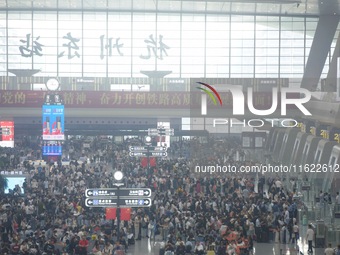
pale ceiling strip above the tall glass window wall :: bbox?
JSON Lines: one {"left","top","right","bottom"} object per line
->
{"left": 0, "top": 0, "right": 340, "bottom": 17}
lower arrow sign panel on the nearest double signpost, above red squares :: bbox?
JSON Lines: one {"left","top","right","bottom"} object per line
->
{"left": 85, "top": 197, "right": 151, "bottom": 207}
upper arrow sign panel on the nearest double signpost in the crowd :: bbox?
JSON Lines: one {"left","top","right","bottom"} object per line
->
{"left": 85, "top": 188, "right": 151, "bottom": 197}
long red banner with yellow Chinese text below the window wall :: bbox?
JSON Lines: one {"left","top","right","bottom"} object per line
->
{"left": 0, "top": 90, "right": 292, "bottom": 109}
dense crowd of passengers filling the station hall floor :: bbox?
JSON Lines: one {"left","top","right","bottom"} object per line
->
{"left": 0, "top": 139, "right": 299, "bottom": 255}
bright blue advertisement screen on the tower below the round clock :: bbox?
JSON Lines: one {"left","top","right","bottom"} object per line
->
{"left": 42, "top": 105, "right": 65, "bottom": 140}
